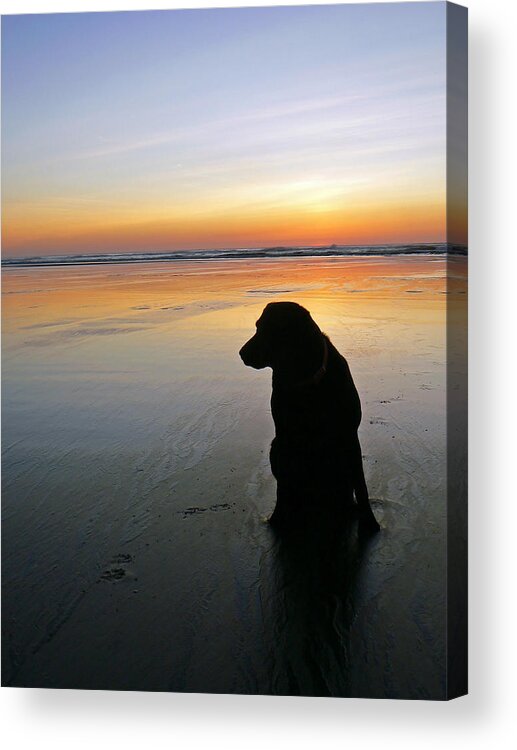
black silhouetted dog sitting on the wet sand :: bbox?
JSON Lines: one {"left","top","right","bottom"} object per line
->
{"left": 239, "top": 302, "right": 379, "bottom": 532}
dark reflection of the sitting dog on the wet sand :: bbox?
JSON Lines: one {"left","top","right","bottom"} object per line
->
{"left": 261, "top": 521, "right": 371, "bottom": 696}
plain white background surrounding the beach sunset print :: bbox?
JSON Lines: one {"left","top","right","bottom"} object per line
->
{"left": 0, "top": 0, "right": 517, "bottom": 750}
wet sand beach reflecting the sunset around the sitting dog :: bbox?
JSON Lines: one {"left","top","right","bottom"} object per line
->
{"left": 2, "top": 256, "right": 465, "bottom": 699}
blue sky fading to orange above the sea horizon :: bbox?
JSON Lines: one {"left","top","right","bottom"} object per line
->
{"left": 2, "top": 3, "right": 463, "bottom": 257}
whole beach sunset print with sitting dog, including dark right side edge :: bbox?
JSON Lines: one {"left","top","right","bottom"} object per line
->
{"left": 2, "top": 2, "right": 467, "bottom": 700}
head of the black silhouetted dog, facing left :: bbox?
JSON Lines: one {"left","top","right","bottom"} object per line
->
{"left": 239, "top": 302, "right": 321, "bottom": 372}
